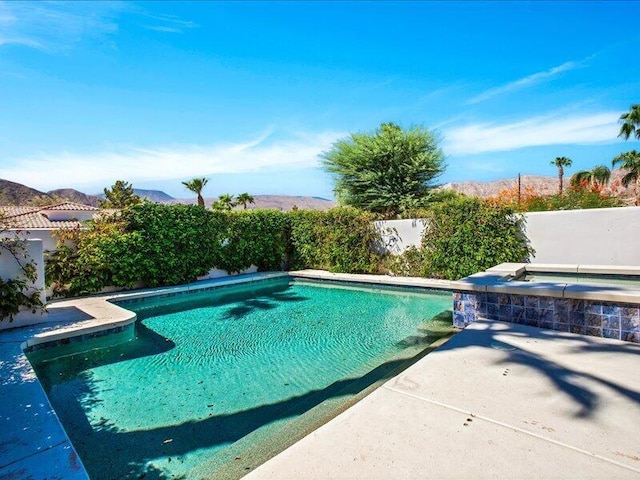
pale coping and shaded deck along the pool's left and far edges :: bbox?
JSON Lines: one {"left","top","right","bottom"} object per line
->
{"left": 0, "top": 270, "right": 451, "bottom": 480}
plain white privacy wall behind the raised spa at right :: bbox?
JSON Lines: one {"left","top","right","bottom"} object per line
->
{"left": 525, "top": 207, "right": 640, "bottom": 265}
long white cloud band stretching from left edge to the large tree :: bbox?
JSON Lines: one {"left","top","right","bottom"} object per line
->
{"left": 0, "top": 131, "right": 344, "bottom": 190}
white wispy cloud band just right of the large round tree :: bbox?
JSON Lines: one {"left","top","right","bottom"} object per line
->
{"left": 444, "top": 112, "right": 620, "bottom": 155}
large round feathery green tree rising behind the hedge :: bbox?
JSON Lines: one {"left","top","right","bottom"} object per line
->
{"left": 322, "top": 123, "right": 445, "bottom": 216}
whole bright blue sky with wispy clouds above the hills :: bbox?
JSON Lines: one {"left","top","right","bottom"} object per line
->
{"left": 0, "top": 1, "right": 640, "bottom": 197}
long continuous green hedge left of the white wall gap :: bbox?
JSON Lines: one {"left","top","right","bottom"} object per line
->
{"left": 46, "top": 203, "right": 379, "bottom": 295}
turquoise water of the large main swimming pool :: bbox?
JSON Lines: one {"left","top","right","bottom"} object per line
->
{"left": 30, "top": 279, "right": 451, "bottom": 479}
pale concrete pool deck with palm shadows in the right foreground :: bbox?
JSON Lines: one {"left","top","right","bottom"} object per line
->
{"left": 245, "top": 321, "right": 640, "bottom": 480}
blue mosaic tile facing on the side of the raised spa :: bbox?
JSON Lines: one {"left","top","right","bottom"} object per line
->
{"left": 453, "top": 292, "right": 640, "bottom": 343}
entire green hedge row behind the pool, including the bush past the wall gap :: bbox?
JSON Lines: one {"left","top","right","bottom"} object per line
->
{"left": 46, "top": 198, "right": 532, "bottom": 296}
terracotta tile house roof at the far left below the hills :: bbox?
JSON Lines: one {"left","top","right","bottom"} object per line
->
{"left": 0, "top": 202, "right": 106, "bottom": 230}
